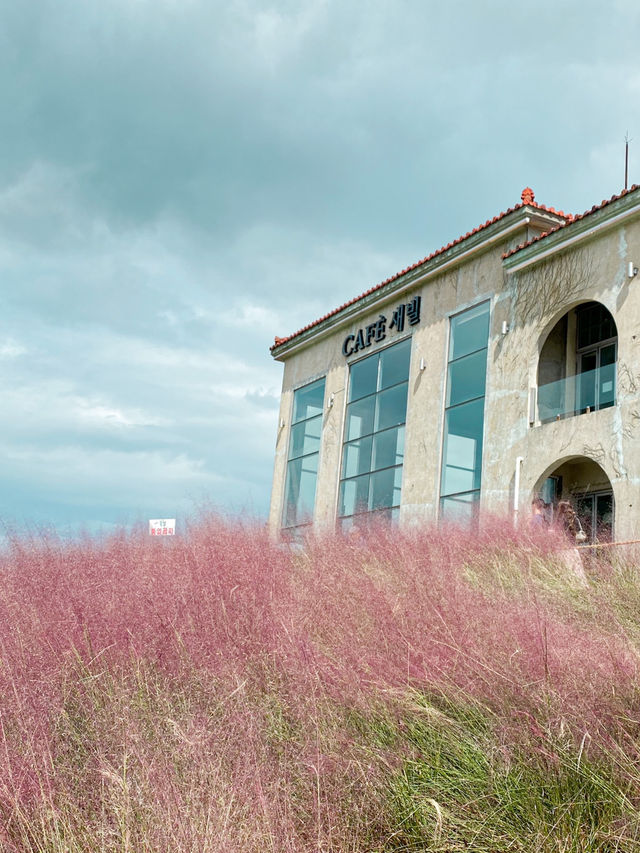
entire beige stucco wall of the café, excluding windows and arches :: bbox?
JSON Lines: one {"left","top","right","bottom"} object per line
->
{"left": 270, "top": 206, "right": 640, "bottom": 538}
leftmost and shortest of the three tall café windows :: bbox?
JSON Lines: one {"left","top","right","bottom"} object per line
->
{"left": 282, "top": 379, "right": 325, "bottom": 527}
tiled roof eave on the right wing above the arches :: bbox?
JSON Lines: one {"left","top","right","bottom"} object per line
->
{"left": 502, "top": 184, "right": 640, "bottom": 273}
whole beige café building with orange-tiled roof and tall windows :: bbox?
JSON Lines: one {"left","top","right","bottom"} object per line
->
{"left": 270, "top": 186, "right": 640, "bottom": 541}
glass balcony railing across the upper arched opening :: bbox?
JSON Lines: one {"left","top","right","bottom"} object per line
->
{"left": 538, "top": 362, "right": 616, "bottom": 423}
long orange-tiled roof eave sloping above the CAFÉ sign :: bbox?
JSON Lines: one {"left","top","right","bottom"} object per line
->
{"left": 271, "top": 203, "right": 566, "bottom": 361}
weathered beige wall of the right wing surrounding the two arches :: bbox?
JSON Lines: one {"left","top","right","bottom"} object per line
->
{"left": 483, "top": 221, "right": 640, "bottom": 539}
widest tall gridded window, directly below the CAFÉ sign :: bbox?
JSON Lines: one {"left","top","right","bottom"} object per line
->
{"left": 338, "top": 338, "right": 411, "bottom": 528}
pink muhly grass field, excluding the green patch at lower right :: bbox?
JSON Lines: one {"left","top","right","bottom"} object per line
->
{"left": 0, "top": 516, "right": 640, "bottom": 851}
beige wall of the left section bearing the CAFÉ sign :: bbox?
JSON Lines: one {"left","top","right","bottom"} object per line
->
{"left": 270, "top": 229, "right": 526, "bottom": 532}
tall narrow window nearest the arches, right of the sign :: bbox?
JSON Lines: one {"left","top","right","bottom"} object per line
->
{"left": 440, "top": 302, "right": 489, "bottom": 520}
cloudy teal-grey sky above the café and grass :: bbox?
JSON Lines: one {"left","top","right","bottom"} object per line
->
{"left": 0, "top": 0, "right": 640, "bottom": 529}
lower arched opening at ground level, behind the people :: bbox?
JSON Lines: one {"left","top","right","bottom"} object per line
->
{"left": 534, "top": 456, "right": 615, "bottom": 544}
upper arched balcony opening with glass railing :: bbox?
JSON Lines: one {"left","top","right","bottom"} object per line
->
{"left": 538, "top": 302, "right": 618, "bottom": 423}
